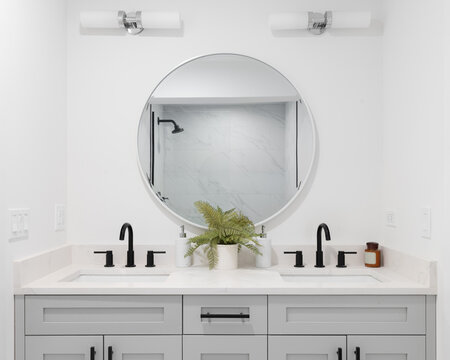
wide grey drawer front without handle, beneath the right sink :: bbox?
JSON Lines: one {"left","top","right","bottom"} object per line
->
{"left": 269, "top": 296, "right": 425, "bottom": 335}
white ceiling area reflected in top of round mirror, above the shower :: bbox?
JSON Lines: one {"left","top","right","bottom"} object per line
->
{"left": 150, "top": 55, "right": 300, "bottom": 104}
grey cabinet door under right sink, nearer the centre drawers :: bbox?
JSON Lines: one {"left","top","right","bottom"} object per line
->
{"left": 269, "top": 336, "right": 347, "bottom": 360}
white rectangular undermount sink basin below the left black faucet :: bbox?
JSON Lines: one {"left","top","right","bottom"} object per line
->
{"left": 64, "top": 274, "right": 169, "bottom": 283}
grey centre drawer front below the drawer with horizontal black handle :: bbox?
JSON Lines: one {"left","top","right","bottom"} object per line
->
{"left": 183, "top": 335, "right": 267, "bottom": 360}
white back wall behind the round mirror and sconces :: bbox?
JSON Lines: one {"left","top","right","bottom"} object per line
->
{"left": 68, "top": 0, "right": 382, "bottom": 243}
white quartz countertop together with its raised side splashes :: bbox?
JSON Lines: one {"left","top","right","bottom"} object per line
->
{"left": 15, "top": 247, "right": 436, "bottom": 295}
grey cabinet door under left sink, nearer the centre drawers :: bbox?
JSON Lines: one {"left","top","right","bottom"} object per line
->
{"left": 105, "top": 335, "right": 182, "bottom": 360}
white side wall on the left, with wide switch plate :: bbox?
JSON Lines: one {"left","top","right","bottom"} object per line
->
{"left": 0, "top": 0, "right": 66, "bottom": 360}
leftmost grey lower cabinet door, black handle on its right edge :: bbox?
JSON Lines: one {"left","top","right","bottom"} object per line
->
{"left": 25, "top": 336, "right": 103, "bottom": 360}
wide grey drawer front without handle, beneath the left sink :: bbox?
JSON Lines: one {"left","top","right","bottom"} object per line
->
{"left": 25, "top": 296, "right": 182, "bottom": 335}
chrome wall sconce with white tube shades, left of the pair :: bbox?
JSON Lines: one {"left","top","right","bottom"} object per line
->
{"left": 80, "top": 10, "right": 181, "bottom": 35}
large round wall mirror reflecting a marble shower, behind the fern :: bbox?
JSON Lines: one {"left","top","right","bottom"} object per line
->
{"left": 138, "top": 54, "right": 315, "bottom": 227}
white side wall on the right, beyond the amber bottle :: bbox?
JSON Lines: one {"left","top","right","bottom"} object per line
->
{"left": 380, "top": 0, "right": 444, "bottom": 360}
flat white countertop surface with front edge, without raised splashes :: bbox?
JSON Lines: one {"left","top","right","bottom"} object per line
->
{"left": 16, "top": 265, "right": 434, "bottom": 295}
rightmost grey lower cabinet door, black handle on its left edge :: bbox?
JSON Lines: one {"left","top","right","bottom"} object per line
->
{"left": 348, "top": 336, "right": 425, "bottom": 360}
